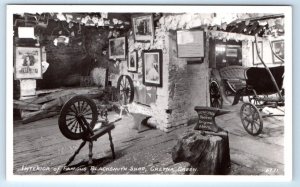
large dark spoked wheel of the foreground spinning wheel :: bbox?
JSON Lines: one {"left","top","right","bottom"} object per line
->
{"left": 58, "top": 95, "right": 98, "bottom": 140}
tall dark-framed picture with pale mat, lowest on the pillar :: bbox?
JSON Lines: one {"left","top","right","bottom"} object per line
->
{"left": 142, "top": 49, "right": 162, "bottom": 87}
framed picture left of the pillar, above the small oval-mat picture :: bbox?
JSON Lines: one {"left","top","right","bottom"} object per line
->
{"left": 108, "top": 37, "right": 126, "bottom": 59}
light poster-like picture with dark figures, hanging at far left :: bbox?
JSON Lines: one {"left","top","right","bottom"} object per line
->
{"left": 15, "top": 47, "right": 42, "bottom": 79}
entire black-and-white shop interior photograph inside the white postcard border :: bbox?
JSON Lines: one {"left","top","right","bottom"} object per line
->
{"left": 13, "top": 12, "right": 285, "bottom": 175}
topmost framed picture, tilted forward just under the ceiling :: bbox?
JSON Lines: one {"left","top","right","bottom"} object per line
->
{"left": 131, "top": 14, "right": 154, "bottom": 42}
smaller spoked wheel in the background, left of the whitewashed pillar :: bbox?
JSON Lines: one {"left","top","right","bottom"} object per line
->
{"left": 117, "top": 75, "right": 134, "bottom": 105}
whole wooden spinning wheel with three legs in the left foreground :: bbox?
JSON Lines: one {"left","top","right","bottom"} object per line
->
{"left": 58, "top": 95, "right": 115, "bottom": 174}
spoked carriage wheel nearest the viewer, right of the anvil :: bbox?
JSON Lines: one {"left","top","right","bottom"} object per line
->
{"left": 240, "top": 103, "right": 263, "bottom": 136}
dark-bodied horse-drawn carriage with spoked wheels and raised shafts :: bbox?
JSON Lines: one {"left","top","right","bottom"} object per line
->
{"left": 210, "top": 37, "right": 284, "bottom": 136}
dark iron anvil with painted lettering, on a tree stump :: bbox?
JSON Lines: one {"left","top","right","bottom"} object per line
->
{"left": 194, "top": 106, "right": 231, "bottom": 132}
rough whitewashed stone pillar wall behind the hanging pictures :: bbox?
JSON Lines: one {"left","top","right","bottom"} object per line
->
{"left": 125, "top": 28, "right": 209, "bottom": 132}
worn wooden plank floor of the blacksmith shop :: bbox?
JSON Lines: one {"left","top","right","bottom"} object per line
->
{"left": 13, "top": 101, "right": 284, "bottom": 175}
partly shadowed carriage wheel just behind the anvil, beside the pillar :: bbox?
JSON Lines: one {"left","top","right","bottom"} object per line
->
{"left": 209, "top": 81, "right": 223, "bottom": 108}
